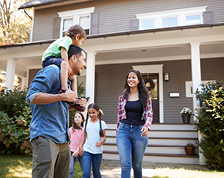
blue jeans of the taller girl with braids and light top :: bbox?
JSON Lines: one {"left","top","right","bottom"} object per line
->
{"left": 82, "top": 151, "right": 102, "bottom": 178}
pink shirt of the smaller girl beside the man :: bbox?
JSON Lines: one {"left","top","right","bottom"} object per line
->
{"left": 69, "top": 127, "right": 84, "bottom": 153}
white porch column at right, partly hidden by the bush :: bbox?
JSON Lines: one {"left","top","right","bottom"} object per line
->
{"left": 191, "top": 42, "right": 205, "bottom": 165}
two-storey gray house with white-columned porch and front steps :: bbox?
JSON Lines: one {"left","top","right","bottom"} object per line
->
{"left": 0, "top": 0, "right": 224, "bottom": 164}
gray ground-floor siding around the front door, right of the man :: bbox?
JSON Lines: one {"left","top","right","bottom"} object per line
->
{"left": 95, "top": 58, "right": 224, "bottom": 123}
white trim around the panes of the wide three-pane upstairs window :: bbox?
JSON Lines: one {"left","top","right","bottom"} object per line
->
{"left": 135, "top": 6, "right": 207, "bottom": 30}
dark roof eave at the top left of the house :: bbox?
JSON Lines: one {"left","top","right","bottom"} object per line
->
{"left": 19, "top": 0, "right": 73, "bottom": 9}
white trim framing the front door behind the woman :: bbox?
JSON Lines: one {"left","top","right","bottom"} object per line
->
{"left": 132, "top": 64, "right": 164, "bottom": 123}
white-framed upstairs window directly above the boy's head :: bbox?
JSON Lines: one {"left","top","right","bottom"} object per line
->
{"left": 58, "top": 7, "right": 95, "bottom": 37}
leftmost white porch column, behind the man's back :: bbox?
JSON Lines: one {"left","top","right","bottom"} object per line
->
{"left": 5, "top": 59, "right": 16, "bottom": 90}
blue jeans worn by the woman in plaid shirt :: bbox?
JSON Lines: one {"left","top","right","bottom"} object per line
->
{"left": 116, "top": 123, "right": 148, "bottom": 178}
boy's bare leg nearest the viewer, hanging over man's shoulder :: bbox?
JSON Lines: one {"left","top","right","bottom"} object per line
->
{"left": 60, "top": 61, "right": 69, "bottom": 90}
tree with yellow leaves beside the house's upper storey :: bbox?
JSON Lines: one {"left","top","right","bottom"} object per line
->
{"left": 0, "top": 0, "right": 31, "bottom": 45}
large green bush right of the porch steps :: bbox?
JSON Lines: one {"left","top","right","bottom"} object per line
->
{"left": 194, "top": 81, "right": 224, "bottom": 170}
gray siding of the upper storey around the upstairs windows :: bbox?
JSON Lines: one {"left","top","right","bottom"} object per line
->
{"left": 33, "top": 0, "right": 224, "bottom": 41}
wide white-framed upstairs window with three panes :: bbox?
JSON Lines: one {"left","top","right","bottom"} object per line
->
{"left": 136, "top": 6, "right": 207, "bottom": 30}
